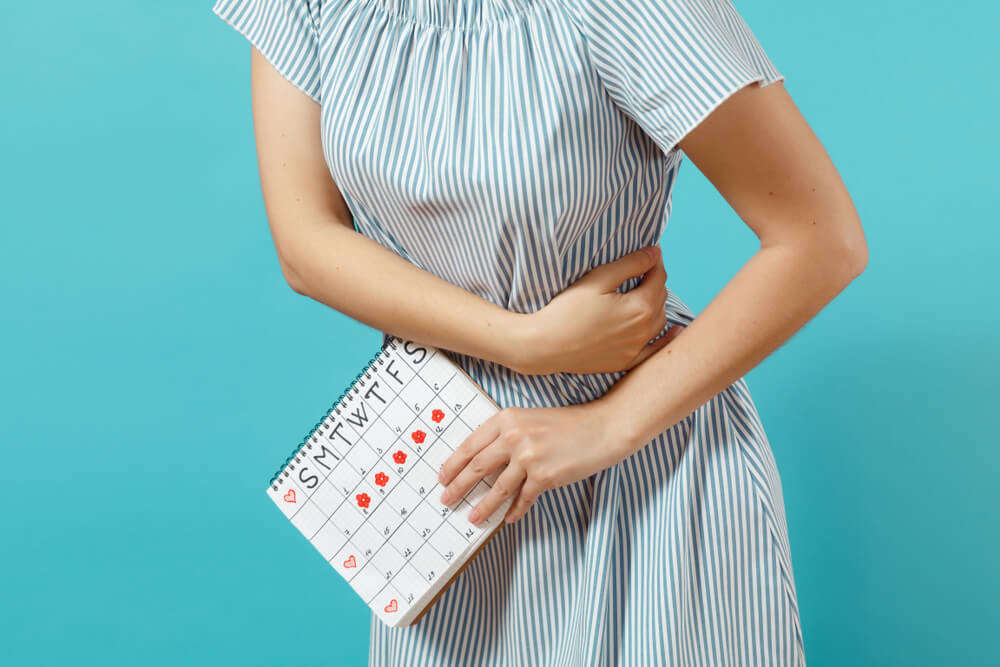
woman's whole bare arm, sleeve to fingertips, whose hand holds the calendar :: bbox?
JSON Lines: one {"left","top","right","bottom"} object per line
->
{"left": 438, "top": 82, "right": 867, "bottom": 523}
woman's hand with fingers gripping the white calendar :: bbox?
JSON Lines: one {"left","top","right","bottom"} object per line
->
{"left": 438, "top": 399, "right": 631, "bottom": 524}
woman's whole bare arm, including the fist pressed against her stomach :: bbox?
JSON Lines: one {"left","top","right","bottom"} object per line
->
{"left": 251, "top": 49, "right": 674, "bottom": 374}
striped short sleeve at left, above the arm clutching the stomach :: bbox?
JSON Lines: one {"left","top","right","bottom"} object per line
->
{"left": 212, "top": 0, "right": 322, "bottom": 102}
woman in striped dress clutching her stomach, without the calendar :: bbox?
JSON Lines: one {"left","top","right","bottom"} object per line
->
{"left": 214, "top": 0, "right": 867, "bottom": 667}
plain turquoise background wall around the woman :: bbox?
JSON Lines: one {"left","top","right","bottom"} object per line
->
{"left": 0, "top": 0, "right": 1000, "bottom": 667}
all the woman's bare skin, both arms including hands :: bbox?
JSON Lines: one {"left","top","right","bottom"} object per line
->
{"left": 244, "top": 48, "right": 868, "bottom": 522}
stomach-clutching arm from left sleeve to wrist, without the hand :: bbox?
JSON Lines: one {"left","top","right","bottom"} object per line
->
{"left": 245, "top": 49, "right": 527, "bottom": 365}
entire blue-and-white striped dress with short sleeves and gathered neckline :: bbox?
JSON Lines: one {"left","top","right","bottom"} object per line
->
{"left": 213, "top": 0, "right": 805, "bottom": 667}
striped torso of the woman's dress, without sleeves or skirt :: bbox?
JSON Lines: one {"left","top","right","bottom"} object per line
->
{"left": 319, "top": 0, "right": 693, "bottom": 407}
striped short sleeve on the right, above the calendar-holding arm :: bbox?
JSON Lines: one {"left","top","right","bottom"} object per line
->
{"left": 566, "top": 0, "right": 785, "bottom": 153}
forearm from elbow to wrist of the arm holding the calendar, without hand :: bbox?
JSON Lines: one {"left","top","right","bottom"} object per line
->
{"left": 597, "top": 237, "right": 863, "bottom": 456}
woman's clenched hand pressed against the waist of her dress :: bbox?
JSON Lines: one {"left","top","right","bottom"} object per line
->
{"left": 515, "top": 246, "right": 684, "bottom": 375}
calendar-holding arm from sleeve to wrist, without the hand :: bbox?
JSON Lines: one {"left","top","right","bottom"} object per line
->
{"left": 597, "top": 77, "right": 868, "bottom": 456}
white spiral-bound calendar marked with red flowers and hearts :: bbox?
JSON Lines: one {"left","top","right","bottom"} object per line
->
{"left": 267, "top": 336, "right": 514, "bottom": 626}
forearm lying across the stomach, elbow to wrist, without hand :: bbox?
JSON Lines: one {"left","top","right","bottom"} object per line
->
{"left": 284, "top": 222, "right": 528, "bottom": 367}
